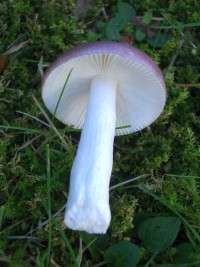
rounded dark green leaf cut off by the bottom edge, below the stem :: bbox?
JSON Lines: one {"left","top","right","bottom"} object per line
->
{"left": 104, "top": 242, "right": 140, "bottom": 267}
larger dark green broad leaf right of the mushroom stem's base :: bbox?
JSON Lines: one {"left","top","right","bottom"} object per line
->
{"left": 138, "top": 217, "right": 181, "bottom": 253}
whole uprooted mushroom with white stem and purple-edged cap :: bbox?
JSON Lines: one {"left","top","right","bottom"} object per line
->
{"left": 42, "top": 41, "right": 166, "bottom": 233}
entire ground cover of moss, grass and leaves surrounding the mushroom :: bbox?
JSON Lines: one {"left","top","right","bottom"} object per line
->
{"left": 0, "top": 0, "right": 200, "bottom": 267}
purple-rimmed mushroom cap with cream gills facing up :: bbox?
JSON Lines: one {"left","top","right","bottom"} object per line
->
{"left": 42, "top": 41, "right": 166, "bottom": 135}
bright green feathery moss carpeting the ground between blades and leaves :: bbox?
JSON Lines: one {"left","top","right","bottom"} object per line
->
{"left": 0, "top": 0, "right": 200, "bottom": 267}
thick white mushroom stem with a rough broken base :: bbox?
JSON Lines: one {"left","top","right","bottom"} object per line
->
{"left": 65, "top": 75, "right": 117, "bottom": 234}
